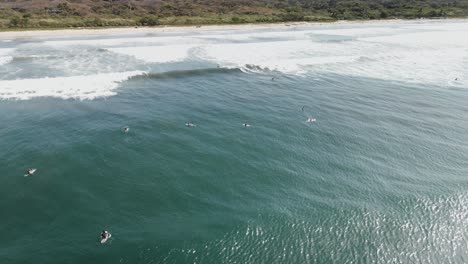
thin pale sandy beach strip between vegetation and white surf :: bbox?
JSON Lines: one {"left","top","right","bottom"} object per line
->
{"left": 0, "top": 18, "right": 468, "bottom": 40}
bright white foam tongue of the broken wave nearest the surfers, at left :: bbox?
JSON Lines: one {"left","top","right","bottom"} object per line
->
{"left": 0, "top": 71, "right": 143, "bottom": 100}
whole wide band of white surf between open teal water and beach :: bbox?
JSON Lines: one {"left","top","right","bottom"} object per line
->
{"left": 0, "top": 21, "right": 468, "bottom": 100}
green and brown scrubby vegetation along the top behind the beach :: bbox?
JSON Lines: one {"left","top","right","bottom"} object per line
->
{"left": 0, "top": 0, "right": 468, "bottom": 29}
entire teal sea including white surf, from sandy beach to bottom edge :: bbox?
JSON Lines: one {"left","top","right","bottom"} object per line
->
{"left": 0, "top": 20, "right": 468, "bottom": 264}
